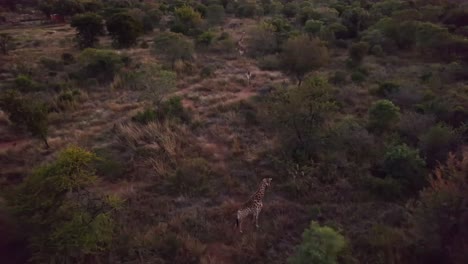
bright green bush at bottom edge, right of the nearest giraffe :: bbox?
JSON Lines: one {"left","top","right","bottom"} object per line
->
{"left": 288, "top": 222, "right": 346, "bottom": 264}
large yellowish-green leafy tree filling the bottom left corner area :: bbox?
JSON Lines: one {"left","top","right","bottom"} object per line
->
{"left": 9, "top": 147, "right": 119, "bottom": 263}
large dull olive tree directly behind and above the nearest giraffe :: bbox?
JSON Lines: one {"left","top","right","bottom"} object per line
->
{"left": 264, "top": 77, "right": 337, "bottom": 161}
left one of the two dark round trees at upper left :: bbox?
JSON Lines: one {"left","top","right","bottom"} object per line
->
{"left": 71, "top": 13, "right": 104, "bottom": 48}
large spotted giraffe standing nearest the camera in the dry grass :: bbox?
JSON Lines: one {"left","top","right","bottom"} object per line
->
{"left": 236, "top": 178, "right": 272, "bottom": 233}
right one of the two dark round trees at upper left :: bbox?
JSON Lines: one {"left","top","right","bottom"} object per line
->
{"left": 106, "top": 13, "right": 143, "bottom": 48}
